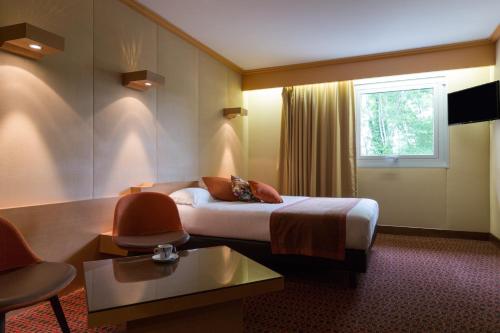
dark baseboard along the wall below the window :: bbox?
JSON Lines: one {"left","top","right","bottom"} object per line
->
{"left": 377, "top": 225, "right": 490, "bottom": 242}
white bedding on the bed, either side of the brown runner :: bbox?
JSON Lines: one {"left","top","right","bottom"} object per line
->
{"left": 177, "top": 196, "right": 378, "bottom": 250}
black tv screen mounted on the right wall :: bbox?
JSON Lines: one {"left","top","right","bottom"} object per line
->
{"left": 448, "top": 81, "right": 500, "bottom": 125}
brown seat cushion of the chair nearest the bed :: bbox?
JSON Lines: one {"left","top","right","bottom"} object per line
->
{"left": 113, "top": 230, "right": 189, "bottom": 250}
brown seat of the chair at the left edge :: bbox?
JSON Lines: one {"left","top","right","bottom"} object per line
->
{"left": 0, "top": 262, "right": 76, "bottom": 312}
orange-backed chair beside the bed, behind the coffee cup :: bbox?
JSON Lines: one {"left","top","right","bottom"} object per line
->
{"left": 113, "top": 192, "right": 189, "bottom": 252}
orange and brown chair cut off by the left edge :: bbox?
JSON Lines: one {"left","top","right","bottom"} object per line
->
{"left": 0, "top": 218, "right": 76, "bottom": 333}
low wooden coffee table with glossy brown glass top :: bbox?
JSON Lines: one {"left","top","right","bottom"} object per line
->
{"left": 83, "top": 246, "right": 284, "bottom": 333}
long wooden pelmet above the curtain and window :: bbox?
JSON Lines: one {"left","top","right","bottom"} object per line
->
{"left": 242, "top": 39, "right": 496, "bottom": 90}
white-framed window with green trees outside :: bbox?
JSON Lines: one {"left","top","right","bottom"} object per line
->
{"left": 355, "top": 77, "right": 448, "bottom": 167}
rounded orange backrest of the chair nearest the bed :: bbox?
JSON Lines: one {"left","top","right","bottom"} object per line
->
{"left": 113, "top": 192, "right": 183, "bottom": 236}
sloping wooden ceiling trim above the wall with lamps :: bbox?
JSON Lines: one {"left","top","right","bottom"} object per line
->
{"left": 120, "top": 0, "right": 243, "bottom": 74}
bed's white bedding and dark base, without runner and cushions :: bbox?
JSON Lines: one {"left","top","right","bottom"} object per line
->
{"left": 177, "top": 196, "right": 379, "bottom": 285}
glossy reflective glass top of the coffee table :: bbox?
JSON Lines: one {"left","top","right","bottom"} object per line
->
{"left": 83, "top": 246, "right": 282, "bottom": 312}
